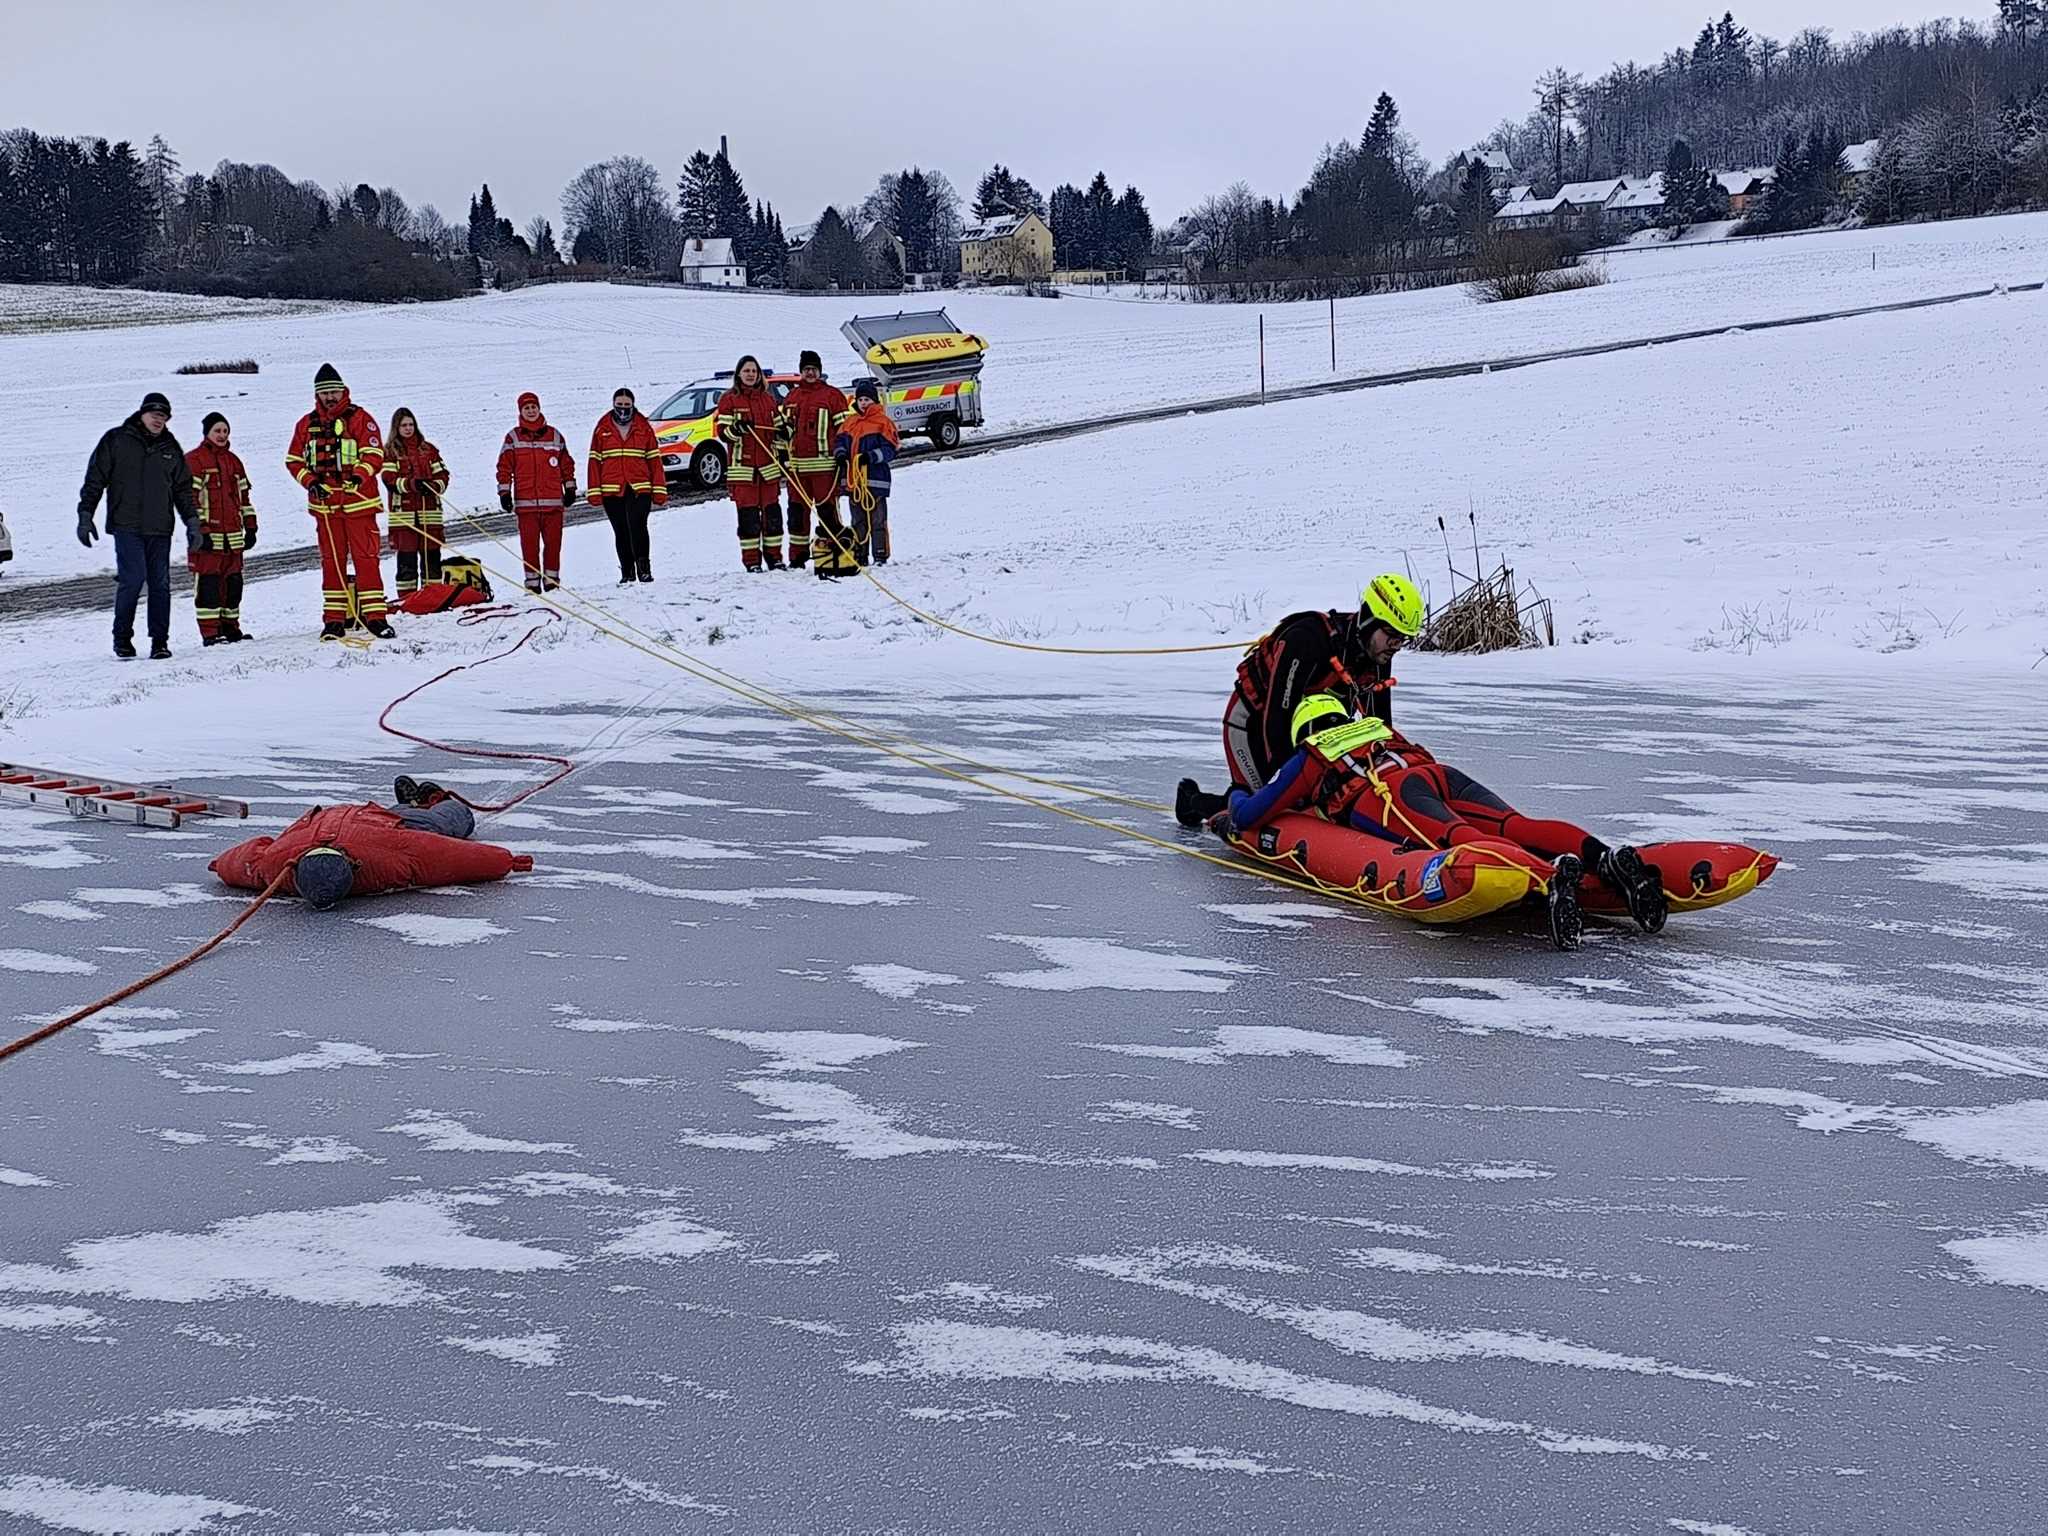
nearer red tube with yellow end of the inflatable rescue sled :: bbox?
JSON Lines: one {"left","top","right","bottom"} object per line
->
{"left": 1231, "top": 813, "right": 1548, "bottom": 924}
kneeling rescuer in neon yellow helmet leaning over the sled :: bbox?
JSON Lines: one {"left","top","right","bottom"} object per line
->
{"left": 1174, "top": 571, "right": 1425, "bottom": 827}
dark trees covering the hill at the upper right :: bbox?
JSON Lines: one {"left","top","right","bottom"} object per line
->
{"left": 1163, "top": 0, "right": 2048, "bottom": 295}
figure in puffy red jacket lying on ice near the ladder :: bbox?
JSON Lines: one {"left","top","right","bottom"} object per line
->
{"left": 207, "top": 778, "right": 532, "bottom": 911}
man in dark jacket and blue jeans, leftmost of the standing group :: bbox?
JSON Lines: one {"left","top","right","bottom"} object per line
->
{"left": 78, "top": 389, "right": 203, "bottom": 662}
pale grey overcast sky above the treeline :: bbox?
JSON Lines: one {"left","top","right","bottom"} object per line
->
{"left": 0, "top": 0, "right": 1995, "bottom": 227}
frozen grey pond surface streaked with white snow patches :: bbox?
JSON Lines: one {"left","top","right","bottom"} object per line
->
{"left": 0, "top": 682, "right": 2048, "bottom": 1532}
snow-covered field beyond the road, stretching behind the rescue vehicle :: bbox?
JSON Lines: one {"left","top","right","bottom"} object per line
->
{"left": 0, "top": 215, "right": 2048, "bottom": 582}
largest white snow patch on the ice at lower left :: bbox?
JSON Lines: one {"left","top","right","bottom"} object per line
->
{"left": 0, "top": 1194, "right": 569, "bottom": 1307}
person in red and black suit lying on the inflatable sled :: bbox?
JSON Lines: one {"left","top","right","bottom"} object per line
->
{"left": 1210, "top": 694, "right": 1665, "bottom": 934}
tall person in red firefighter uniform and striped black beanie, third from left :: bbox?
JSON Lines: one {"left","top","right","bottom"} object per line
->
{"left": 285, "top": 362, "right": 397, "bottom": 641}
